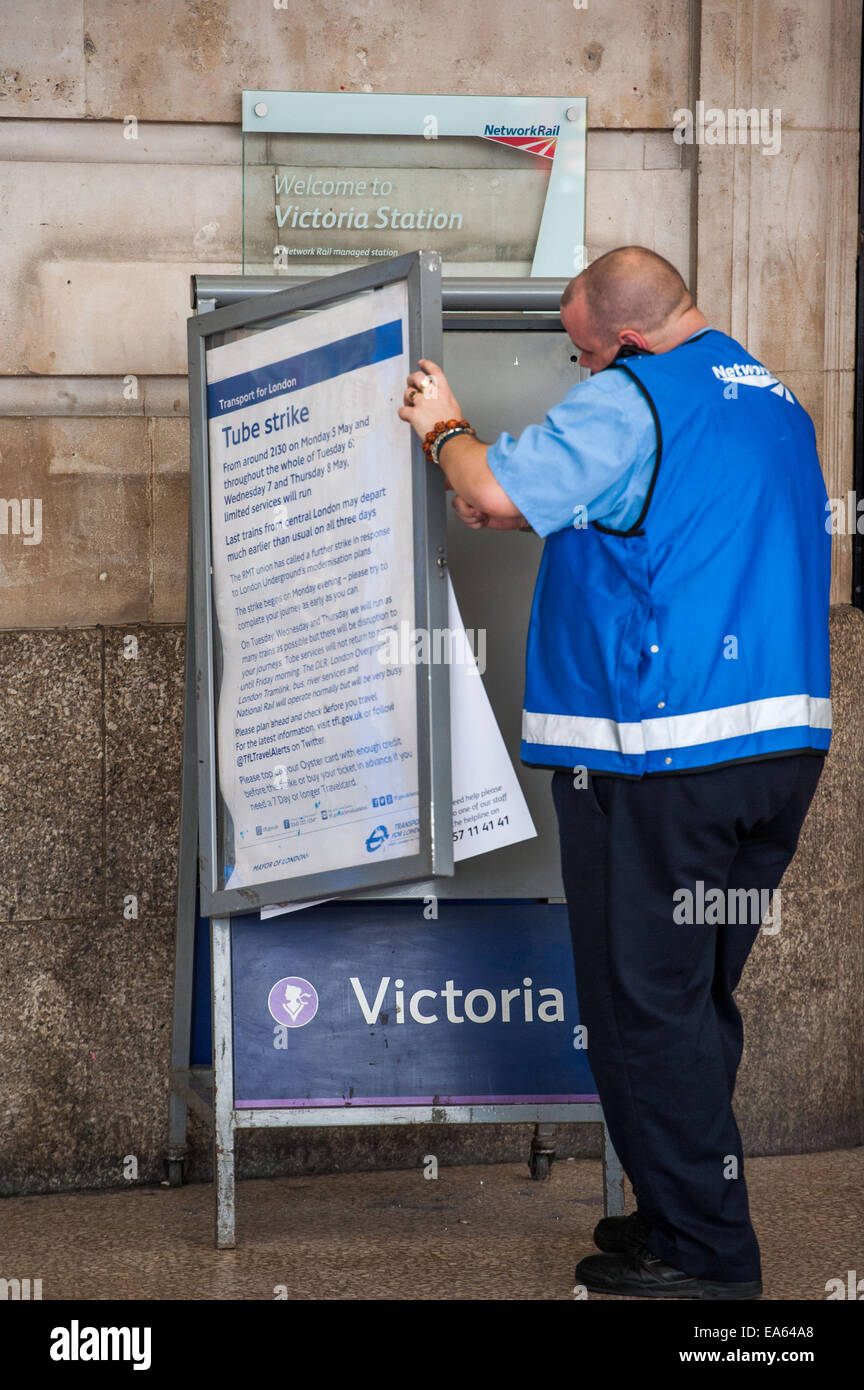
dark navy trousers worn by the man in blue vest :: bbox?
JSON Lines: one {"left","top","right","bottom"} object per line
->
{"left": 551, "top": 753, "right": 824, "bottom": 1282}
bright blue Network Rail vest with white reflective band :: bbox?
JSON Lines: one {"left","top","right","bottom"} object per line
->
{"left": 521, "top": 329, "right": 831, "bottom": 777}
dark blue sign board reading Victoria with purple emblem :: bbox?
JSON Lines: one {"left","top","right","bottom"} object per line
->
{"left": 231, "top": 901, "right": 597, "bottom": 1109}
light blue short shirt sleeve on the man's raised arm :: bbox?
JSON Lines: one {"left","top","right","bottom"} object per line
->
{"left": 486, "top": 368, "right": 657, "bottom": 537}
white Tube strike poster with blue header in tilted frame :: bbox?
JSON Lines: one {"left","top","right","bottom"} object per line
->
{"left": 207, "top": 282, "right": 419, "bottom": 888}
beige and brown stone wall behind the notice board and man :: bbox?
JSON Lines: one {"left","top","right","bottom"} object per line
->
{"left": 0, "top": 0, "right": 864, "bottom": 1191}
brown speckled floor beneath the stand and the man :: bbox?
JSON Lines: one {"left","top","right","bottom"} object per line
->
{"left": 0, "top": 1150, "right": 864, "bottom": 1300}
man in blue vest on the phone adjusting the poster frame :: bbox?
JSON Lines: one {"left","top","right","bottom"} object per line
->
{"left": 399, "top": 246, "right": 831, "bottom": 1300}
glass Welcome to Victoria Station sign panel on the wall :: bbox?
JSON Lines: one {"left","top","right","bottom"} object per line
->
{"left": 243, "top": 92, "right": 586, "bottom": 277}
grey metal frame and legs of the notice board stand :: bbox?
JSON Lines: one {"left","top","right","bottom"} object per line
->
{"left": 167, "top": 252, "right": 624, "bottom": 1250}
